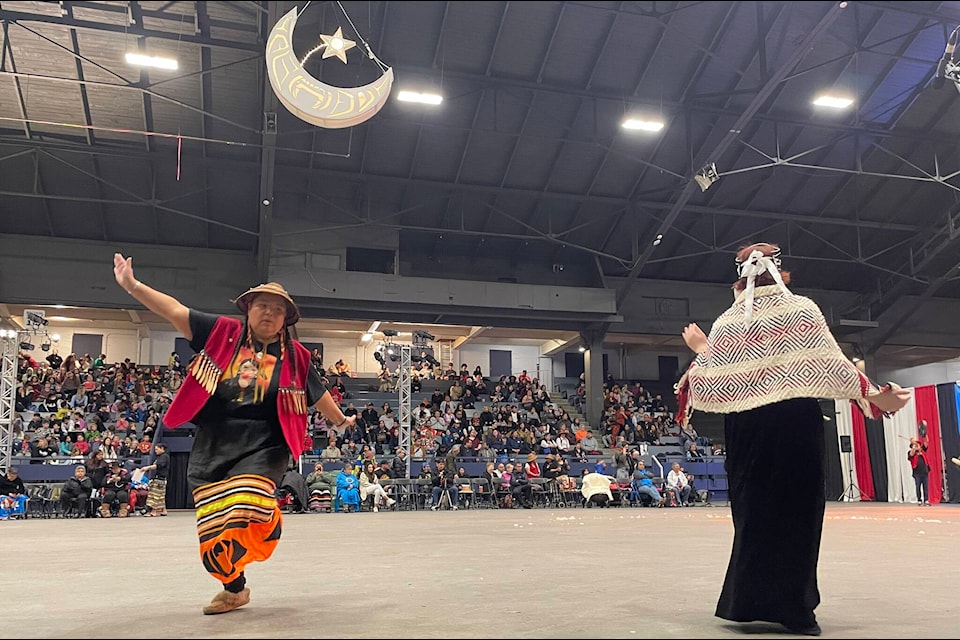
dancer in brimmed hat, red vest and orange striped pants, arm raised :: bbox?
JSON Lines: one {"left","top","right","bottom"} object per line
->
{"left": 113, "top": 253, "right": 354, "bottom": 615}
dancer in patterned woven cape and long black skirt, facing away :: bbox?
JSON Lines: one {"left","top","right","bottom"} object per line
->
{"left": 676, "top": 243, "right": 910, "bottom": 635}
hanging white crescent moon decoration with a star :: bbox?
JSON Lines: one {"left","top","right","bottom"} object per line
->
{"left": 266, "top": 7, "right": 393, "bottom": 129}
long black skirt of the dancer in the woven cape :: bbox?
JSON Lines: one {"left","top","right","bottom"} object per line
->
{"left": 716, "top": 398, "right": 826, "bottom": 627}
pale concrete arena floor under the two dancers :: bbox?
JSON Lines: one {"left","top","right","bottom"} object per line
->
{"left": 7, "top": 503, "right": 960, "bottom": 638}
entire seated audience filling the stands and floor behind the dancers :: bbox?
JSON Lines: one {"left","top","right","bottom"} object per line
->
{"left": 3, "top": 340, "right": 703, "bottom": 517}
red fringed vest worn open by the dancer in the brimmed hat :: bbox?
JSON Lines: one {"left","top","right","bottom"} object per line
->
{"left": 163, "top": 316, "right": 310, "bottom": 459}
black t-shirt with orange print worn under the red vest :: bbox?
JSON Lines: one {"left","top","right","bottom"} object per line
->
{"left": 187, "top": 309, "right": 327, "bottom": 490}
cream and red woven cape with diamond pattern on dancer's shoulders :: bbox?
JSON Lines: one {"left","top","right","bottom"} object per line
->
{"left": 675, "top": 285, "right": 882, "bottom": 425}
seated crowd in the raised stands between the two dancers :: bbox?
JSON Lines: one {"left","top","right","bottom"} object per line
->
{"left": 308, "top": 363, "right": 696, "bottom": 476}
